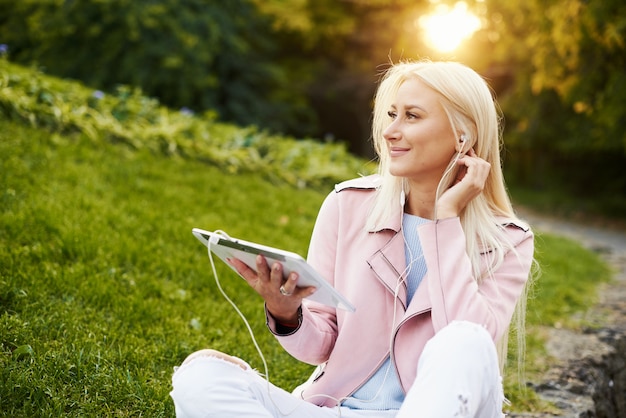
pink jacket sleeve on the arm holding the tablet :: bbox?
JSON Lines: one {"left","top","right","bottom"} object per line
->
{"left": 267, "top": 192, "right": 339, "bottom": 365}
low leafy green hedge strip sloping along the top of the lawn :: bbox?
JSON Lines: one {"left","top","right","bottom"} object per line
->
{"left": 0, "top": 60, "right": 372, "bottom": 193}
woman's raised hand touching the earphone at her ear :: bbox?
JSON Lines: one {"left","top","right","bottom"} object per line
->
{"left": 437, "top": 149, "right": 491, "bottom": 219}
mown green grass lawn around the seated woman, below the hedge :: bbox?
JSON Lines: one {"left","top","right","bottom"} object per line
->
{"left": 0, "top": 119, "right": 609, "bottom": 417}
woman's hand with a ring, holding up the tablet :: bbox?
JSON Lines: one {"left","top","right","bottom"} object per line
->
{"left": 228, "top": 255, "right": 316, "bottom": 325}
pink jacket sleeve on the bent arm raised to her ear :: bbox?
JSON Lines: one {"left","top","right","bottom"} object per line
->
{"left": 419, "top": 218, "right": 534, "bottom": 341}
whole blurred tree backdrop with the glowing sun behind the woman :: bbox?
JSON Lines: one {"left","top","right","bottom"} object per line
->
{"left": 0, "top": 0, "right": 626, "bottom": 220}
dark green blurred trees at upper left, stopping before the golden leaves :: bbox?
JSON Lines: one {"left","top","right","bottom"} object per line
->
{"left": 0, "top": 0, "right": 315, "bottom": 134}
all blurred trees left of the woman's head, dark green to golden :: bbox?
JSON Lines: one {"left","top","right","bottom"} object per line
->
{"left": 0, "top": 0, "right": 442, "bottom": 152}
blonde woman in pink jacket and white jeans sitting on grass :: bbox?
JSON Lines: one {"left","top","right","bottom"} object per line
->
{"left": 172, "top": 62, "right": 533, "bottom": 418}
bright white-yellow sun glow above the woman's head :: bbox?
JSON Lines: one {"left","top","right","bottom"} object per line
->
{"left": 416, "top": 1, "right": 480, "bottom": 52}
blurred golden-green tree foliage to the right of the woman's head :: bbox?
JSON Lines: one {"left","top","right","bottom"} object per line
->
{"left": 476, "top": 0, "right": 626, "bottom": 220}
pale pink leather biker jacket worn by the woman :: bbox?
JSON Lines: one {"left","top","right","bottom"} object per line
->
{"left": 268, "top": 176, "right": 534, "bottom": 406}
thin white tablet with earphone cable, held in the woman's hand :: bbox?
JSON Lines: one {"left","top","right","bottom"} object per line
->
{"left": 192, "top": 228, "right": 355, "bottom": 312}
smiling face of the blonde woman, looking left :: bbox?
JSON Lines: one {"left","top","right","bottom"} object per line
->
{"left": 383, "top": 78, "right": 458, "bottom": 184}
